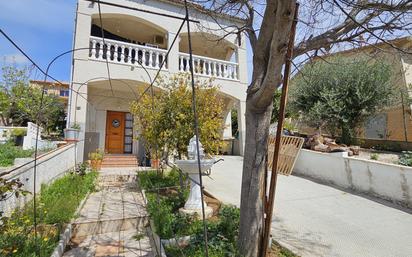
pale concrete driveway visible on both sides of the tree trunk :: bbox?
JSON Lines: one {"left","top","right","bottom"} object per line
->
{"left": 203, "top": 156, "right": 412, "bottom": 257}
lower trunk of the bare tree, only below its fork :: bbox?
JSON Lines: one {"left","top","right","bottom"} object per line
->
{"left": 239, "top": 102, "right": 272, "bottom": 257}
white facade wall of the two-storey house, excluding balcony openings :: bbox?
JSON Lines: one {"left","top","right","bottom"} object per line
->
{"left": 68, "top": 0, "right": 248, "bottom": 158}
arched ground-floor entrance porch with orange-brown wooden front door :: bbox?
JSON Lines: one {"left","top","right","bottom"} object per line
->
{"left": 85, "top": 79, "right": 161, "bottom": 156}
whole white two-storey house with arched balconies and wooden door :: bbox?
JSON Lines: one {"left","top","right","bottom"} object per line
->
{"left": 68, "top": 0, "right": 248, "bottom": 160}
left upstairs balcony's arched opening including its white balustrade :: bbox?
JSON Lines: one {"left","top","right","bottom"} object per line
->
{"left": 89, "top": 14, "right": 168, "bottom": 69}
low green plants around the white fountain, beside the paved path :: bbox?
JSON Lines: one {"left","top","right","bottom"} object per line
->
{"left": 139, "top": 170, "right": 240, "bottom": 254}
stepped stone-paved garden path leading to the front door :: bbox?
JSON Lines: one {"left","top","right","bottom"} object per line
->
{"left": 64, "top": 168, "right": 154, "bottom": 257}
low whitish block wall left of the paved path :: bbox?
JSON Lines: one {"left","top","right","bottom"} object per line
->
{"left": 0, "top": 144, "right": 76, "bottom": 215}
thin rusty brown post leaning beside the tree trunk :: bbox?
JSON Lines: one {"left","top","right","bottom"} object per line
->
{"left": 262, "top": 3, "right": 299, "bottom": 254}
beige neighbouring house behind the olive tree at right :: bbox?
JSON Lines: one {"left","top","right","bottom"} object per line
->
{"left": 298, "top": 37, "right": 412, "bottom": 142}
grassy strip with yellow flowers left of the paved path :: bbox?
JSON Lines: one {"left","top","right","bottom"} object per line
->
{"left": 0, "top": 169, "right": 97, "bottom": 257}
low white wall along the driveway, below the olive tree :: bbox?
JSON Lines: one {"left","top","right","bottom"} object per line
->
{"left": 293, "top": 149, "right": 412, "bottom": 208}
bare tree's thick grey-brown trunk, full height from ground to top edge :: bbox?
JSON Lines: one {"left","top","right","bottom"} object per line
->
{"left": 238, "top": 0, "right": 296, "bottom": 257}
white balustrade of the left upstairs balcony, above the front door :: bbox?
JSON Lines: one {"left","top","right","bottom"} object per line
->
{"left": 89, "top": 36, "right": 168, "bottom": 70}
